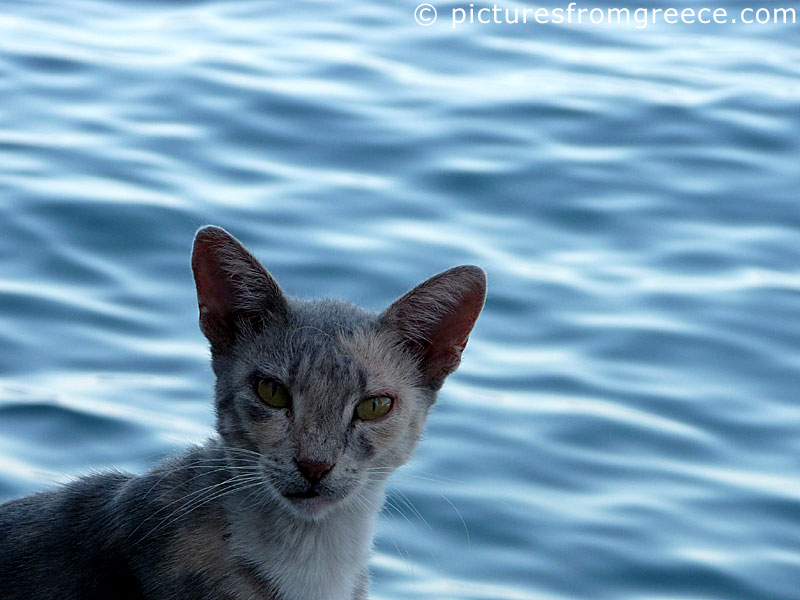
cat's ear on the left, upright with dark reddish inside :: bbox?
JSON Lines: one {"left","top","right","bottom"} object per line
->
{"left": 192, "top": 225, "right": 288, "bottom": 350}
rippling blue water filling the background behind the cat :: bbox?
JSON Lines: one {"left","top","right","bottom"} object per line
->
{"left": 0, "top": 0, "right": 800, "bottom": 600}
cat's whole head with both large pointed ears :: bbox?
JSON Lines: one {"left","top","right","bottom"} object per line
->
{"left": 192, "top": 227, "right": 486, "bottom": 518}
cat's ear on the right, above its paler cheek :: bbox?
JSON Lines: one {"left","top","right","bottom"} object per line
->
{"left": 379, "top": 265, "right": 486, "bottom": 390}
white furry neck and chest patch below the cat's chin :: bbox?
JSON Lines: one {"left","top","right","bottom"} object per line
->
{"left": 220, "top": 454, "right": 384, "bottom": 600}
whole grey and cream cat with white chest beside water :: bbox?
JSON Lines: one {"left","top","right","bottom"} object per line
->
{"left": 0, "top": 226, "right": 486, "bottom": 600}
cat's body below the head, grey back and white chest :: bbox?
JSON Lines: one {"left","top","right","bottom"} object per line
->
{"left": 0, "top": 441, "right": 379, "bottom": 600}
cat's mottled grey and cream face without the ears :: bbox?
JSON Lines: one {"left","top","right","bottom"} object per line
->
{"left": 209, "top": 303, "right": 433, "bottom": 514}
